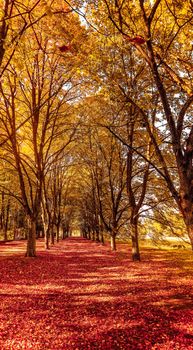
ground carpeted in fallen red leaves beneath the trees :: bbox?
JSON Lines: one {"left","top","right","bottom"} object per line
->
{"left": 0, "top": 238, "right": 193, "bottom": 350}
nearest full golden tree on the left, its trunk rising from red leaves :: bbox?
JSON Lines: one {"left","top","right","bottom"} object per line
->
{"left": 0, "top": 24, "right": 80, "bottom": 256}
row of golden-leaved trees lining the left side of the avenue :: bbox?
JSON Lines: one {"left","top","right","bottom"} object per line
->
{"left": 0, "top": 1, "right": 85, "bottom": 256}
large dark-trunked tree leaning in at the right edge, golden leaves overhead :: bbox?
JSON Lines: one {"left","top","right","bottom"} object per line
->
{"left": 80, "top": 0, "right": 193, "bottom": 247}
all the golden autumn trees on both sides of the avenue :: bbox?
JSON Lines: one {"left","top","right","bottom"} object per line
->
{"left": 0, "top": 0, "right": 193, "bottom": 260}
